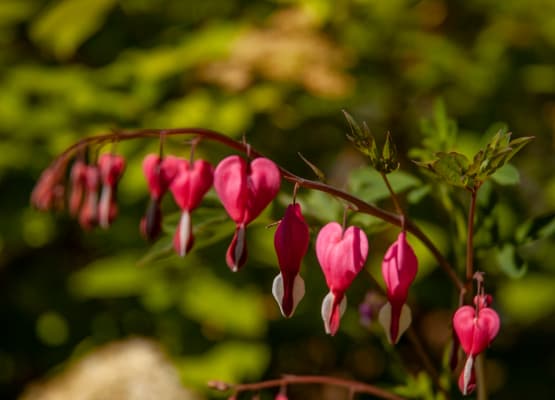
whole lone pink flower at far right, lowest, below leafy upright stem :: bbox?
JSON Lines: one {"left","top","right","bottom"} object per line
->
{"left": 453, "top": 295, "right": 501, "bottom": 395}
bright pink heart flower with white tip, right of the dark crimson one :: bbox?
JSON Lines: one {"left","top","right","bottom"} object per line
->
{"left": 316, "top": 222, "right": 368, "bottom": 336}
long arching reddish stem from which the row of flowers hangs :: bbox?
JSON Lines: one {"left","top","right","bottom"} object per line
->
{"left": 40, "top": 128, "right": 465, "bottom": 290}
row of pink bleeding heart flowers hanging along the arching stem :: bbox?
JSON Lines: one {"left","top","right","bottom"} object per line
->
{"left": 32, "top": 144, "right": 426, "bottom": 343}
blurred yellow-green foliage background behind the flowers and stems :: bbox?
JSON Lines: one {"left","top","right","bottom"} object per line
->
{"left": 0, "top": 0, "right": 555, "bottom": 399}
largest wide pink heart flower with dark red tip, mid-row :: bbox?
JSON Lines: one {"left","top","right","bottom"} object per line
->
{"left": 214, "top": 156, "right": 281, "bottom": 272}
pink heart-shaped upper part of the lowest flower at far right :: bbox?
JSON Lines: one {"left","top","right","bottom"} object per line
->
{"left": 453, "top": 306, "right": 500, "bottom": 356}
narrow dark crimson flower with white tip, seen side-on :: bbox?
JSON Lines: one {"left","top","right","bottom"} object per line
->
{"left": 272, "top": 203, "right": 310, "bottom": 317}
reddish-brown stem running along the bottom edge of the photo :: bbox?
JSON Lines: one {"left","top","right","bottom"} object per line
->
{"left": 208, "top": 375, "right": 403, "bottom": 400}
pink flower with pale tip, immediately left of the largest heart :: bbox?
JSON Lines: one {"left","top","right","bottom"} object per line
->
{"left": 170, "top": 159, "right": 214, "bottom": 257}
